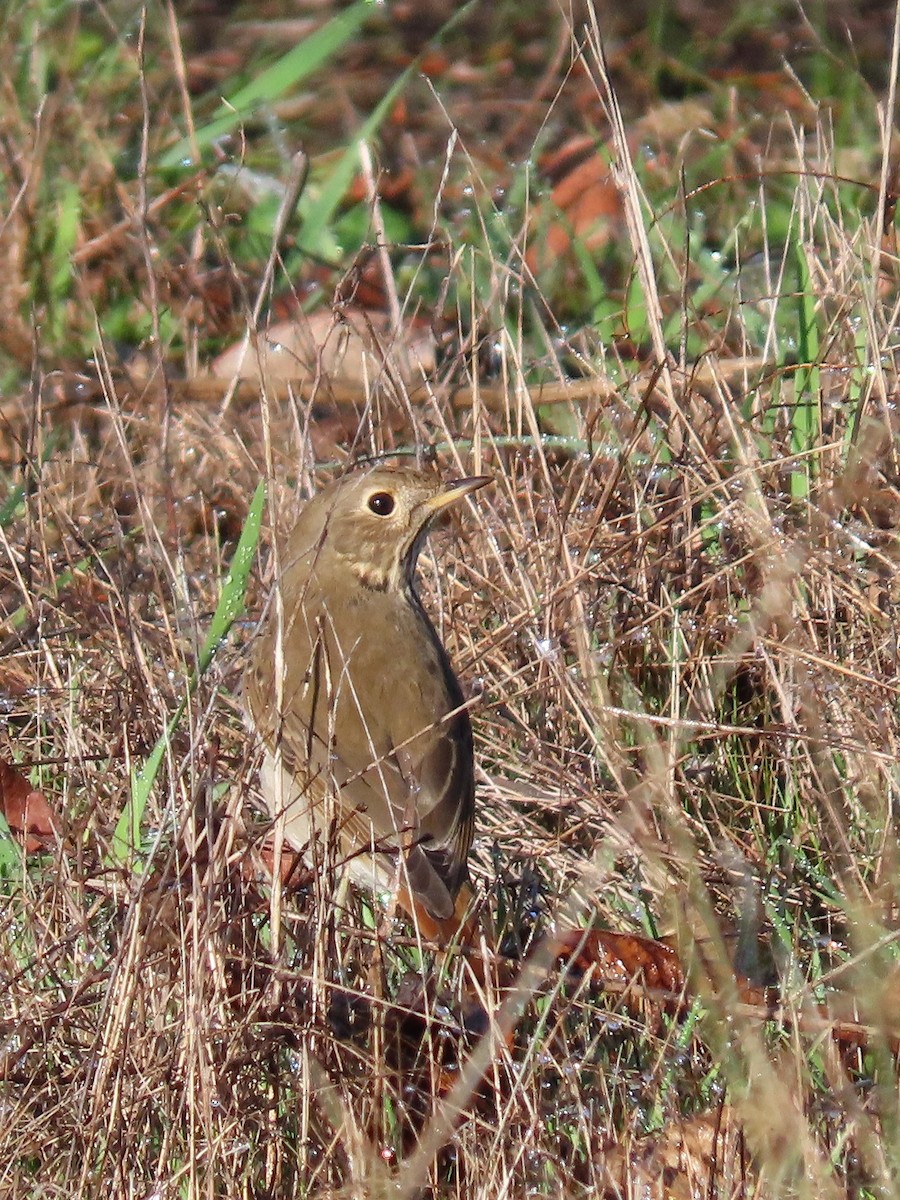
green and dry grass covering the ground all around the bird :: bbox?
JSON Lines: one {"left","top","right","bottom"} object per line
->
{"left": 0, "top": 0, "right": 900, "bottom": 1198}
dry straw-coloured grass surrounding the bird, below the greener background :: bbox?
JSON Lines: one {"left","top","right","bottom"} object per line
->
{"left": 0, "top": 2, "right": 900, "bottom": 1200}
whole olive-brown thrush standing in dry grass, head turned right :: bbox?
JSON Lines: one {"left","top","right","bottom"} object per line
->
{"left": 245, "top": 466, "right": 491, "bottom": 936}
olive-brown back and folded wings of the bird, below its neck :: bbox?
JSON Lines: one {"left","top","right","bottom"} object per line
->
{"left": 246, "top": 590, "right": 474, "bottom": 918}
